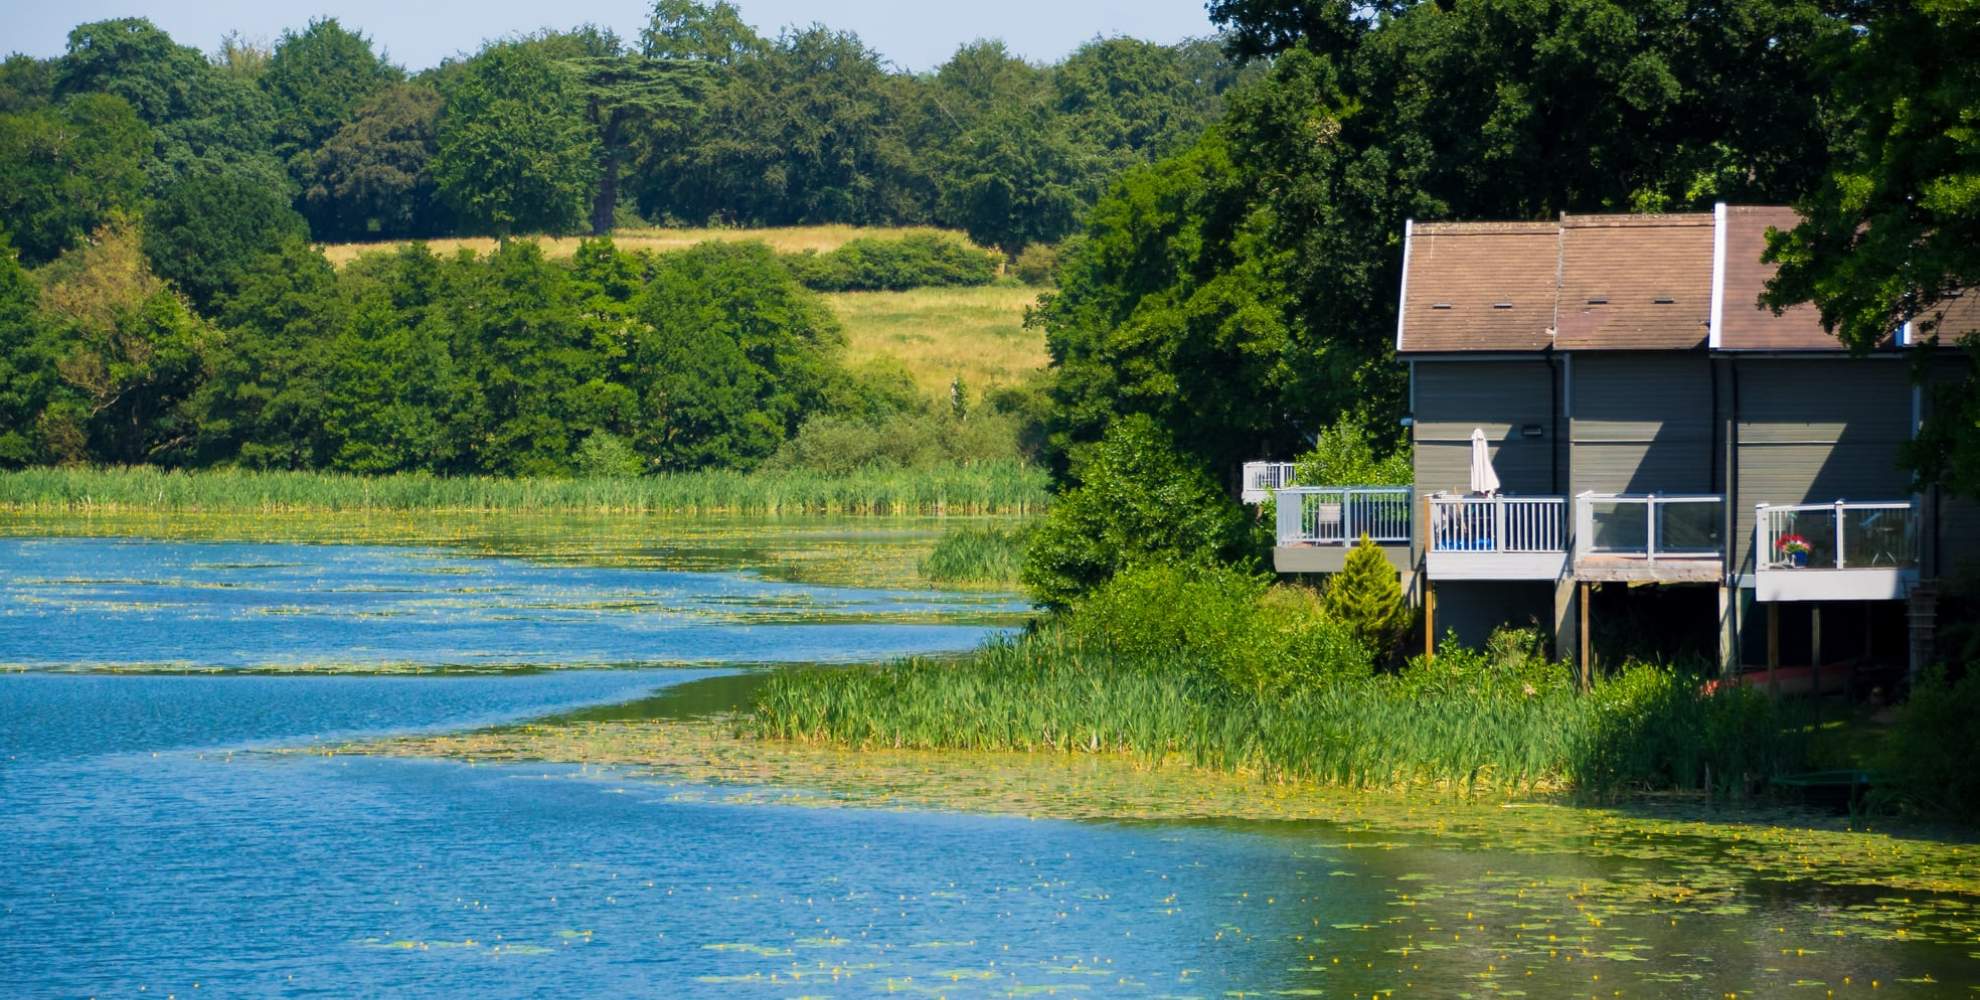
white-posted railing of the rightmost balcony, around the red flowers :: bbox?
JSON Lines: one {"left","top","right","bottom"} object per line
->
{"left": 1754, "top": 501, "right": 1919, "bottom": 572}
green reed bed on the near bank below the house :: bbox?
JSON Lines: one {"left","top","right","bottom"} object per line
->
{"left": 743, "top": 628, "right": 1800, "bottom": 794}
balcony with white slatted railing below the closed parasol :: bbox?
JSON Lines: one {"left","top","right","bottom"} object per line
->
{"left": 1424, "top": 493, "right": 1568, "bottom": 580}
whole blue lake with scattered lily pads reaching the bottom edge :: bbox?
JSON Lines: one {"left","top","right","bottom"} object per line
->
{"left": 0, "top": 525, "right": 1980, "bottom": 998}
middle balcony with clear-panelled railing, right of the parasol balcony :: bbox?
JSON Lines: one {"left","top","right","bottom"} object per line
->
{"left": 1574, "top": 493, "right": 1725, "bottom": 584}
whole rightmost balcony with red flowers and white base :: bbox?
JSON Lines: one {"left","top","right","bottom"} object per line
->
{"left": 1752, "top": 501, "right": 1919, "bottom": 600}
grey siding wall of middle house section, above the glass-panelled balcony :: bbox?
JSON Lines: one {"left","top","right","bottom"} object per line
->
{"left": 1568, "top": 352, "right": 1717, "bottom": 493}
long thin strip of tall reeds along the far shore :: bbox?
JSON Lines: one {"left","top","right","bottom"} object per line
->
{"left": 0, "top": 461, "right": 1045, "bottom": 515}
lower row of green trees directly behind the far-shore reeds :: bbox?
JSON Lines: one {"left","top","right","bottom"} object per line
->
{"left": 0, "top": 220, "right": 1026, "bottom": 477}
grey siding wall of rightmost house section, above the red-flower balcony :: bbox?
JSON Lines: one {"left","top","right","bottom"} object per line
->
{"left": 1733, "top": 356, "right": 1911, "bottom": 572}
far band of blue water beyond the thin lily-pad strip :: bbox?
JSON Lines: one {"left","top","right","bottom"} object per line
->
{"left": 0, "top": 539, "right": 1022, "bottom": 667}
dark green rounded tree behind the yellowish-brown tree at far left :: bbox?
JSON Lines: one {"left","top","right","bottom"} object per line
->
{"left": 145, "top": 174, "right": 309, "bottom": 309}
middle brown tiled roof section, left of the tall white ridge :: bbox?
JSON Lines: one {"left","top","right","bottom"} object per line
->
{"left": 1554, "top": 212, "right": 1713, "bottom": 350}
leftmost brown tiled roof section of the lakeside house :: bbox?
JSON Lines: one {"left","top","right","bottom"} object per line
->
{"left": 1396, "top": 222, "right": 1558, "bottom": 352}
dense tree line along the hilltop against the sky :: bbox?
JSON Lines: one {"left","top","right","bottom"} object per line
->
{"left": 0, "top": 0, "right": 1239, "bottom": 257}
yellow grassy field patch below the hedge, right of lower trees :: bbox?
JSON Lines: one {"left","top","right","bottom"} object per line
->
{"left": 826, "top": 285, "right": 1045, "bottom": 396}
